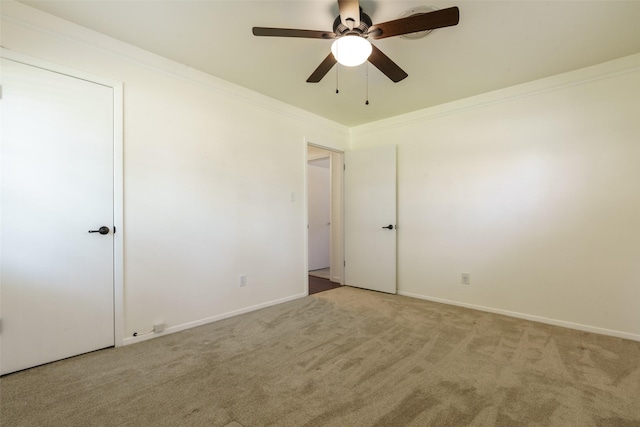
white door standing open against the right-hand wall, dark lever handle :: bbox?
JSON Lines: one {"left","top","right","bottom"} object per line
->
{"left": 344, "top": 145, "right": 396, "bottom": 294}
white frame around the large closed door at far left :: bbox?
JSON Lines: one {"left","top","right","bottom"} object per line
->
{"left": 0, "top": 48, "right": 124, "bottom": 347}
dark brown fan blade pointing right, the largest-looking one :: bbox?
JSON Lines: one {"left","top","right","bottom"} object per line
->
{"left": 369, "top": 7, "right": 460, "bottom": 39}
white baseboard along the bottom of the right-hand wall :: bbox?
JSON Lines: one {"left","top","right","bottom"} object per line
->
{"left": 398, "top": 291, "right": 640, "bottom": 341}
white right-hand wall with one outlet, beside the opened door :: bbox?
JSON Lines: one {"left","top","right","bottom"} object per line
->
{"left": 352, "top": 55, "right": 640, "bottom": 339}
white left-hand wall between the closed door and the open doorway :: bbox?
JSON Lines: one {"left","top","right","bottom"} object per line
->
{"left": 2, "top": 2, "right": 348, "bottom": 342}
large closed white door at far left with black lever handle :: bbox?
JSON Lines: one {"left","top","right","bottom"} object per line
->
{"left": 0, "top": 59, "right": 115, "bottom": 374}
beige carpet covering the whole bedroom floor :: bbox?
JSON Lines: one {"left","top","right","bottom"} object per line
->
{"left": 0, "top": 287, "right": 640, "bottom": 427}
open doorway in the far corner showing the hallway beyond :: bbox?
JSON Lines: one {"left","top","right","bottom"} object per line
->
{"left": 306, "top": 144, "right": 344, "bottom": 294}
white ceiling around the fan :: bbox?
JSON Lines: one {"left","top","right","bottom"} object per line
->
{"left": 17, "top": 0, "right": 640, "bottom": 126}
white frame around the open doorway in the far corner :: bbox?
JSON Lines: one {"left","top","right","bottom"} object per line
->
{"left": 304, "top": 137, "right": 344, "bottom": 295}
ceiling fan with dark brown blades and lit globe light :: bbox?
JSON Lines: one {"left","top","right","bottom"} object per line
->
{"left": 253, "top": 0, "right": 460, "bottom": 83}
